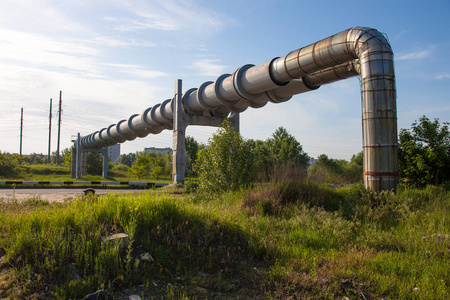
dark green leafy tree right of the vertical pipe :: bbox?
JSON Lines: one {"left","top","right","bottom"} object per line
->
{"left": 399, "top": 116, "right": 450, "bottom": 186}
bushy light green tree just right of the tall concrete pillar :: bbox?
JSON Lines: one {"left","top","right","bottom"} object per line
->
{"left": 194, "top": 121, "right": 256, "bottom": 193}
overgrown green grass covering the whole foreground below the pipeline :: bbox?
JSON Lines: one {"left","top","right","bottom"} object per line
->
{"left": 0, "top": 178, "right": 450, "bottom": 299}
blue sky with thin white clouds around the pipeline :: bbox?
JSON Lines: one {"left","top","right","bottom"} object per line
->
{"left": 0, "top": 0, "right": 450, "bottom": 160}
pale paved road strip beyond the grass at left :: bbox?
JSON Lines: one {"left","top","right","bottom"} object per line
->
{"left": 0, "top": 188, "right": 143, "bottom": 202}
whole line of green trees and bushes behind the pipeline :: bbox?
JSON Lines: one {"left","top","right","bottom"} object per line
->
{"left": 0, "top": 116, "right": 450, "bottom": 187}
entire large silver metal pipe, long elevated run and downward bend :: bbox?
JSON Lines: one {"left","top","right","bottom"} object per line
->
{"left": 81, "top": 27, "right": 398, "bottom": 191}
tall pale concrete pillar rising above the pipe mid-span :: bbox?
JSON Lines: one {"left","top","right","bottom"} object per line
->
{"left": 172, "top": 79, "right": 187, "bottom": 184}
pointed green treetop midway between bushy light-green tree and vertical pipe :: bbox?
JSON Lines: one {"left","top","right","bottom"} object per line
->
{"left": 267, "top": 127, "right": 309, "bottom": 168}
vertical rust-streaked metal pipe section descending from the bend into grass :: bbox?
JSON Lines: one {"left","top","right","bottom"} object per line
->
{"left": 349, "top": 31, "right": 399, "bottom": 191}
